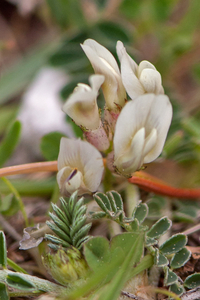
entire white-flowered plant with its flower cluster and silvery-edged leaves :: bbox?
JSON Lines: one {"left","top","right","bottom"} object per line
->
{"left": 0, "top": 39, "right": 200, "bottom": 300}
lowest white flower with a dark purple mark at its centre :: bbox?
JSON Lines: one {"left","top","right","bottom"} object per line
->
{"left": 57, "top": 138, "right": 104, "bottom": 196}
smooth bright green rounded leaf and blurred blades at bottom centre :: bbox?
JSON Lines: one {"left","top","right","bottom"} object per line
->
{"left": 68, "top": 233, "right": 144, "bottom": 299}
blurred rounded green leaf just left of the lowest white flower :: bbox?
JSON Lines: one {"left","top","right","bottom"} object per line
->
{"left": 40, "top": 132, "right": 64, "bottom": 161}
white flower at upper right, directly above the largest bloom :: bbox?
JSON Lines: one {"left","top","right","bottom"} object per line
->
{"left": 117, "top": 41, "right": 164, "bottom": 99}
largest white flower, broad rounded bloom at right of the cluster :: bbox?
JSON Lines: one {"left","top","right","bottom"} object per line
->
{"left": 113, "top": 94, "right": 172, "bottom": 176}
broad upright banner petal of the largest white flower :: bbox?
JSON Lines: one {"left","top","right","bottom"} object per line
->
{"left": 113, "top": 94, "right": 172, "bottom": 175}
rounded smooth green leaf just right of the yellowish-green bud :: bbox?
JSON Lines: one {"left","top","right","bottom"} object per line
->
{"left": 83, "top": 236, "right": 111, "bottom": 271}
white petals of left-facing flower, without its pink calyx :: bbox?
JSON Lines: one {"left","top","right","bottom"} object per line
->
{"left": 63, "top": 75, "right": 104, "bottom": 130}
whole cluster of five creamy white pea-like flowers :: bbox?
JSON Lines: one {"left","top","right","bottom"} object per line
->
{"left": 57, "top": 39, "right": 172, "bottom": 195}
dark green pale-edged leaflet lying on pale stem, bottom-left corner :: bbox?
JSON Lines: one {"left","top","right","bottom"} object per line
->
{"left": 6, "top": 273, "right": 35, "bottom": 290}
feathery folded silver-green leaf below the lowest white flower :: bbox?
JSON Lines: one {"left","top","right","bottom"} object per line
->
{"left": 45, "top": 192, "right": 91, "bottom": 250}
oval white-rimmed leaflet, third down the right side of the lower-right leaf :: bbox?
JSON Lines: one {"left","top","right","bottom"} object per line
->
{"left": 159, "top": 233, "right": 187, "bottom": 255}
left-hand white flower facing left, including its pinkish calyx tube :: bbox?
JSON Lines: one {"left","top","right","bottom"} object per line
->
{"left": 63, "top": 75, "right": 110, "bottom": 151}
